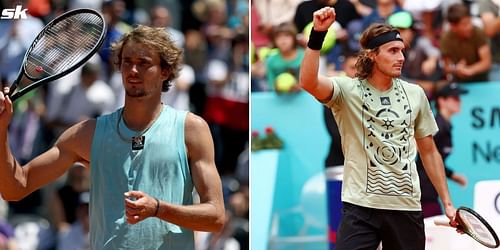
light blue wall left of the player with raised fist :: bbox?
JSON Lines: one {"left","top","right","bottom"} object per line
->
{"left": 251, "top": 92, "right": 330, "bottom": 210}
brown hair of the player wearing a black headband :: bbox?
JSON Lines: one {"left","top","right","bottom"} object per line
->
{"left": 356, "top": 23, "right": 397, "bottom": 79}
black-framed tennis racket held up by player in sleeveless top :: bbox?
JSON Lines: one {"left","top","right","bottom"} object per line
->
{"left": 8, "top": 9, "right": 106, "bottom": 102}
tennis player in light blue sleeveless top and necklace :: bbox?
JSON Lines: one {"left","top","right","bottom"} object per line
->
{"left": 0, "top": 14, "right": 224, "bottom": 250}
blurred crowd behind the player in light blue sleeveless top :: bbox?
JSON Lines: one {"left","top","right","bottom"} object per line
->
{"left": 0, "top": 0, "right": 250, "bottom": 250}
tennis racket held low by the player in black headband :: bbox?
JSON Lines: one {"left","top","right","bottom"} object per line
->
{"left": 434, "top": 207, "right": 500, "bottom": 248}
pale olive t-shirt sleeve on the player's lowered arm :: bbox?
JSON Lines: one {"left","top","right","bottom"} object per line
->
{"left": 415, "top": 87, "right": 438, "bottom": 139}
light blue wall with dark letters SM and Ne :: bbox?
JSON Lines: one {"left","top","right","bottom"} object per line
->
{"left": 446, "top": 82, "right": 500, "bottom": 207}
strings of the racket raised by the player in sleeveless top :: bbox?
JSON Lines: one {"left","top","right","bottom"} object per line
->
{"left": 26, "top": 13, "right": 104, "bottom": 79}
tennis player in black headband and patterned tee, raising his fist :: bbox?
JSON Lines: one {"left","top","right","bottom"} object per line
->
{"left": 300, "top": 7, "right": 456, "bottom": 250}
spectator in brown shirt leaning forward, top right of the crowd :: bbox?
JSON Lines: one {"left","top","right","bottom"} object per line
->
{"left": 440, "top": 3, "right": 491, "bottom": 82}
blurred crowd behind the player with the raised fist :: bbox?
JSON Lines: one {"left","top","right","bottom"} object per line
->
{"left": 250, "top": 0, "right": 500, "bottom": 96}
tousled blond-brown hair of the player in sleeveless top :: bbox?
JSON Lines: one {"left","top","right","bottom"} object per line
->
{"left": 111, "top": 25, "right": 182, "bottom": 92}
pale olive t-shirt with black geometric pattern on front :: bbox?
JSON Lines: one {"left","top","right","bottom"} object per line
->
{"left": 325, "top": 77, "right": 438, "bottom": 211}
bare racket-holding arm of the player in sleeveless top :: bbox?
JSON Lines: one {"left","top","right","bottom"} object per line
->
{"left": 0, "top": 90, "right": 95, "bottom": 201}
